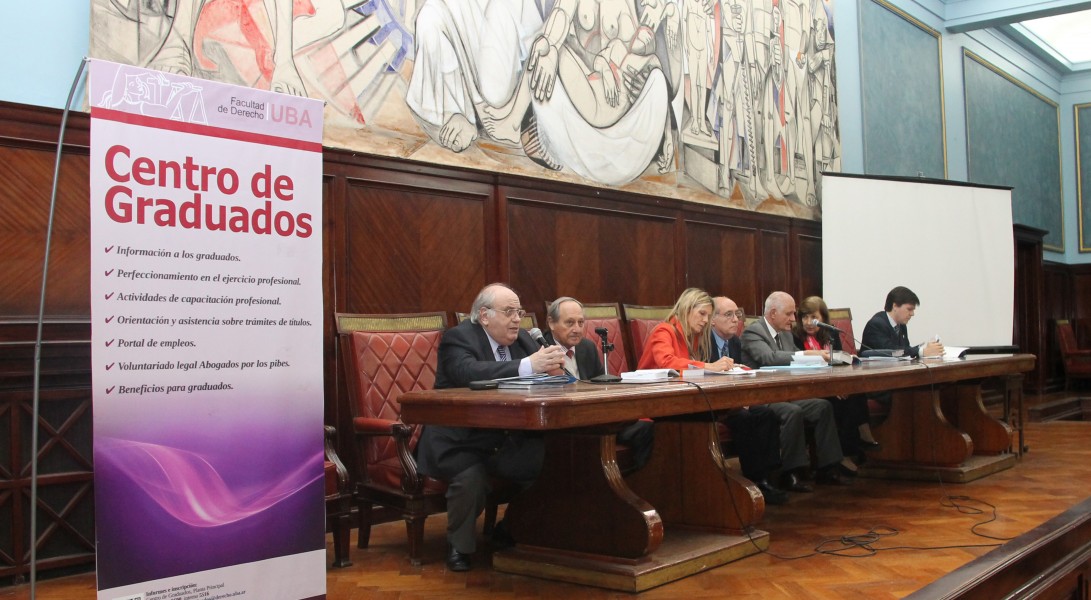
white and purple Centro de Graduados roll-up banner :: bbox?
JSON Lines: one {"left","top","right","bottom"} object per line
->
{"left": 89, "top": 60, "right": 325, "bottom": 600}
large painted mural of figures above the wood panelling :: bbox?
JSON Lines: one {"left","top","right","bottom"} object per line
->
{"left": 92, "top": 0, "right": 840, "bottom": 218}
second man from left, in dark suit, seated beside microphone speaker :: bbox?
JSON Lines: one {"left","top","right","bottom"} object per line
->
{"left": 544, "top": 296, "right": 655, "bottom": 475}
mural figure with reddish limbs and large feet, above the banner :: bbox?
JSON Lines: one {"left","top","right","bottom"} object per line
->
{"left": 147, "top": 0, "right": 347, "bottom": 96}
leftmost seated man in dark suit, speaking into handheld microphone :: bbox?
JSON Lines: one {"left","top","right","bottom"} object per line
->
{"left": 417, "top": 284, "right": 564, "bottom": 571}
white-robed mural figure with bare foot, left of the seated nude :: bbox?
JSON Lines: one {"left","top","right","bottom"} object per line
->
{"left": 406, "top": 0, "right": 542, "bottom": 152}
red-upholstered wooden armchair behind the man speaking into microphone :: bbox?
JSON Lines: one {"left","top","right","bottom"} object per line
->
{"left": 336, "top": 312, "right": 447, "bottom": 565}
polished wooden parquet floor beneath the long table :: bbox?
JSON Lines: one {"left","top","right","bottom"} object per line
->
{"left": 0, "top": 421, "right": 1091, "bottom": 600}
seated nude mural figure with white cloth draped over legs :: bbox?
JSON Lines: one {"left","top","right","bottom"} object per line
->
{"left": 482, "top": 0, "right": 681, "bottom": 184}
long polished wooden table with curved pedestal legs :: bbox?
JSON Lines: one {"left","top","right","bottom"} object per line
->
{"left": 400, "top": 355, "right": 1034, "bottom": 591}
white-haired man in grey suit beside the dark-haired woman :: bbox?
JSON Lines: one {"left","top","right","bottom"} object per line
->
{"left": 742, "top": 291, "right": 847, "bottom": 492}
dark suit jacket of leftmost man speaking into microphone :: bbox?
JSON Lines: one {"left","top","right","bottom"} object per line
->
{"left": 417, "top": 320, "right": 538, "bottom": 480}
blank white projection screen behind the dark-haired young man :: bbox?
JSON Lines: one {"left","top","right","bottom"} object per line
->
{"left": 823, "top": 173, "right": 1015, "bottom": 348}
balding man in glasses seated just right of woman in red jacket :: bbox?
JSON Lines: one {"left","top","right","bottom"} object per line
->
{"left": 710, "top": 296, "right": 788, "bottom": 504}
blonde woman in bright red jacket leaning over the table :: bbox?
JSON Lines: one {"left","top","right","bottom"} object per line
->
{"left": 637, "top": 288, "right": 734, "bottom": 371}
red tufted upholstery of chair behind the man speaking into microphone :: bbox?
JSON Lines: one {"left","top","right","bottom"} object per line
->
{"left": 337, "top": 312, "right": 447, "bottom": 489}
